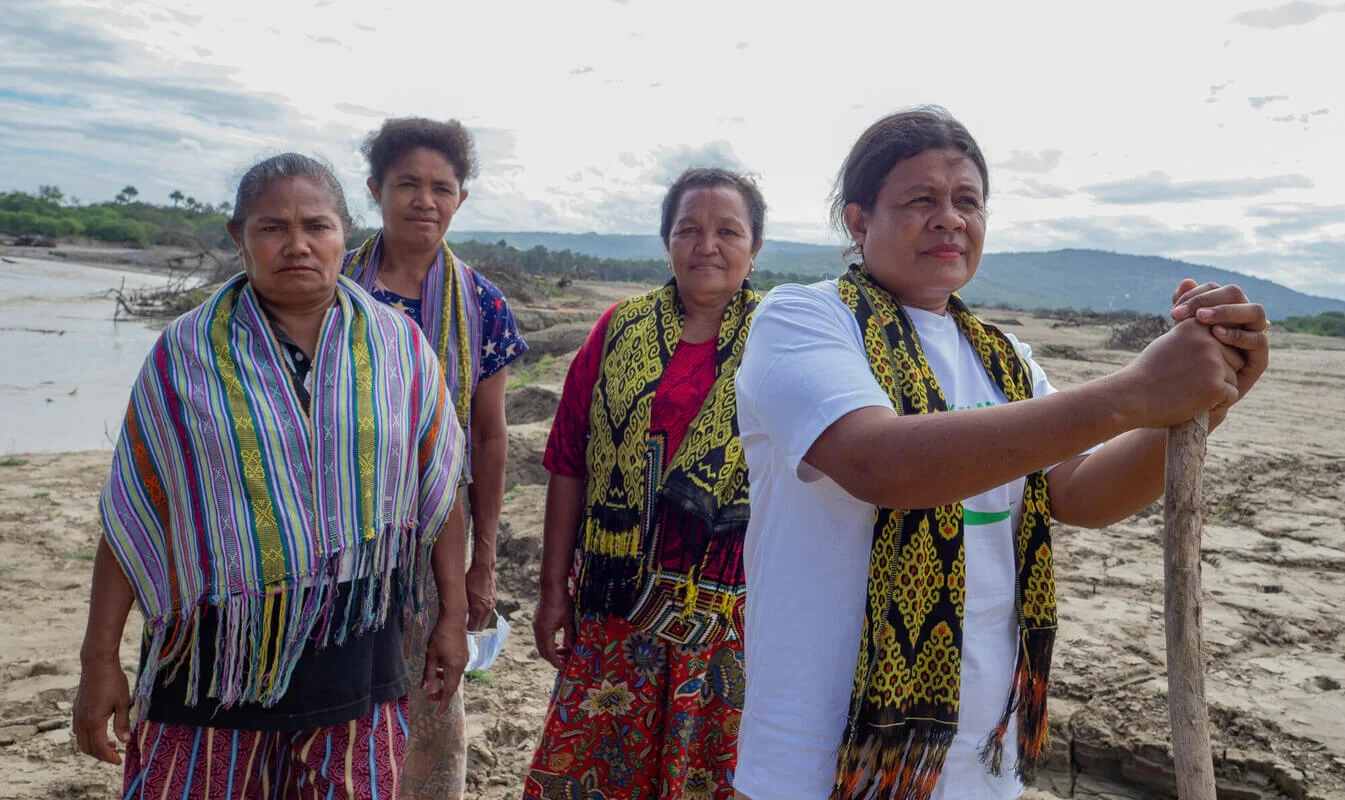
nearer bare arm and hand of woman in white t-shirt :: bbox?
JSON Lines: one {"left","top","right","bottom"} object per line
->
{"left": 806, "top": 323, "right": 1237, "bottom": 508}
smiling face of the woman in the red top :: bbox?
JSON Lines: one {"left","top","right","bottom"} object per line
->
{"left": 668, "top": 186, "right": 761, "bottom": 305}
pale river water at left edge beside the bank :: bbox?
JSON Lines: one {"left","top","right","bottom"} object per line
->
{"left": 0, "top": 258, "right": 167, "bottom": 457}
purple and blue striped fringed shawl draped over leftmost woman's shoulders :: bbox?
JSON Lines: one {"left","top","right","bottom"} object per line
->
{"left": 100, "top": 276, "right": 464, "bottom": 714}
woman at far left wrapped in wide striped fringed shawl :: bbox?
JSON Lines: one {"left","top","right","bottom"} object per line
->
{"left": 75, "top": 153, "right": 467, "bottom": 800}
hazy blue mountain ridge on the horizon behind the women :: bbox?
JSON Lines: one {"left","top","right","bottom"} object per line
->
{"left": 448, "top": 231, "right": 1345, "bottom": 320}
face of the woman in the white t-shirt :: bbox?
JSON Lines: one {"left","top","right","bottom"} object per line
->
{"left": 845, "top": 149, "right": 986, "bottom": 313}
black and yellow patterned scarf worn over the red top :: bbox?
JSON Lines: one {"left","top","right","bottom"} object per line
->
{"left": 578, "top": 281, "right": 757, "bottom": 614}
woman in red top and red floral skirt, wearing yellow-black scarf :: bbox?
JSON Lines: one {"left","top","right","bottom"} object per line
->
{"left": 523, "top": 169, "right": 765, "bottom": 800}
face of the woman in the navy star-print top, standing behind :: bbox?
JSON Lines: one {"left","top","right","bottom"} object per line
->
{"left": 369, "top": 148, "right": 467, "bottom": 250}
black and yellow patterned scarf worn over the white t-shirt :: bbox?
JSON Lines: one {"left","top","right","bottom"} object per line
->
{"left": 831, "top": 266, "right": 1056, "bottom": 800}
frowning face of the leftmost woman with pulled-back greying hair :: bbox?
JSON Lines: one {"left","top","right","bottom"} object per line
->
{"left": 229, "top": 177, "right": 346, "bottom": 307}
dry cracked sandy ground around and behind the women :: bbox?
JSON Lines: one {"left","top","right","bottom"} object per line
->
{"left": 0, "top": 285, "right": 1345, "bottom": 800}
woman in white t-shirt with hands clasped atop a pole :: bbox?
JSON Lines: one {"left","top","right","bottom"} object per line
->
{"left": 734, "top": 109, "right": 1267, "bottom": 800}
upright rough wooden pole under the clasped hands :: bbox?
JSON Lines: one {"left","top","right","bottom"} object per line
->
{"left": 1163, "top": 414, "right": 1216, "bottom": 800}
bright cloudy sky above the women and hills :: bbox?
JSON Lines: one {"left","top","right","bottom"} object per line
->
{"left": 0, "top": 0, "right": 1345, "bottom": 297}
